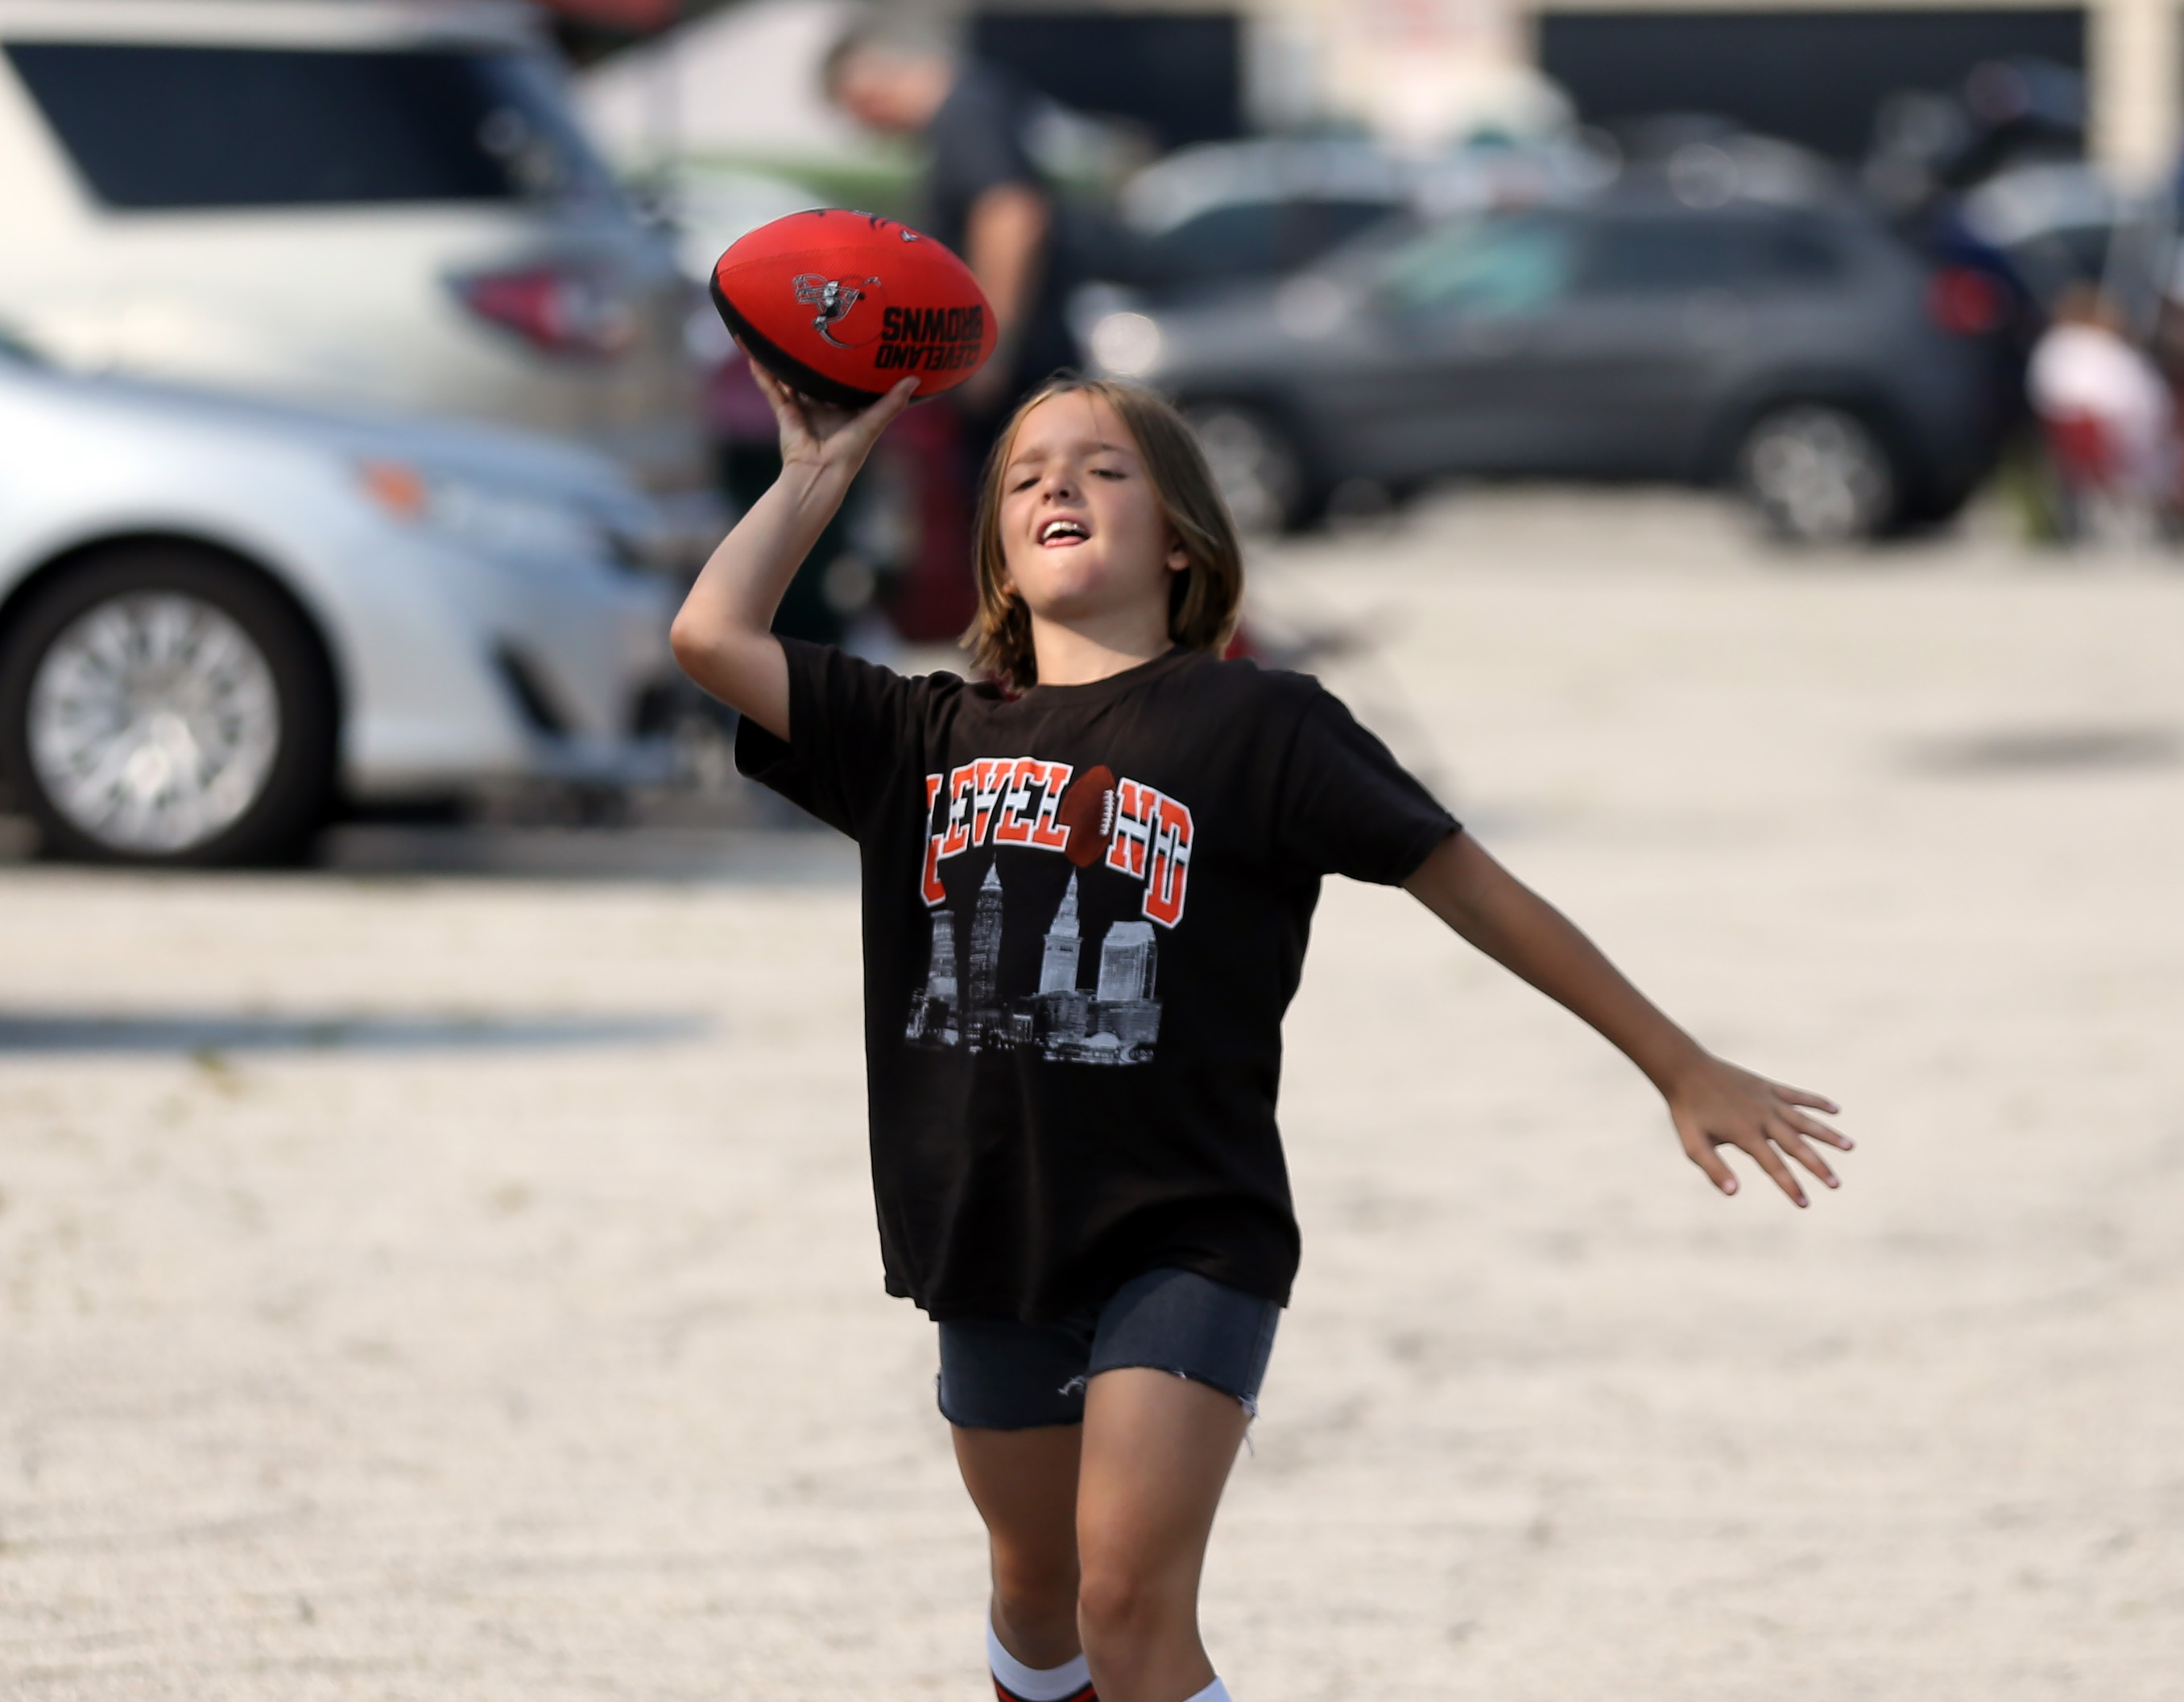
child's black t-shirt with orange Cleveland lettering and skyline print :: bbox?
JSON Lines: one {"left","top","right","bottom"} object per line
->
{"left": 736, "top": 640, "right": 1457, "bottom": 1320}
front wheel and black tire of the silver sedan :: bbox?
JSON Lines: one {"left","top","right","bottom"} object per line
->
{"left": 0, "top": 544, "right": 337, "bottom": 867}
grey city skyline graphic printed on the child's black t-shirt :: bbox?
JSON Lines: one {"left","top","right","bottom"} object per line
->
{"left": 904, "top": 857, "right": 1160, "bottom": 1064}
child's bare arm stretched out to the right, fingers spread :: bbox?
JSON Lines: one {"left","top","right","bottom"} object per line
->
{"left": 1404, "top": 832, "right": 1850, "bottom": 1206}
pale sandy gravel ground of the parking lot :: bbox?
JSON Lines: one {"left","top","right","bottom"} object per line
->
{"left": 0, "top": 494, "right": 2184, "bottom": 1702}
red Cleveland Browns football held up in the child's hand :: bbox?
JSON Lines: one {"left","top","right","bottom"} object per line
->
{"left": 712, "top": 208, "right": 994, "bottom": 408}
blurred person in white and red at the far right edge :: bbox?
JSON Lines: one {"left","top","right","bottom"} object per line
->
{"left": 2027, "top": 284, "right": 2178, "bottom": 538}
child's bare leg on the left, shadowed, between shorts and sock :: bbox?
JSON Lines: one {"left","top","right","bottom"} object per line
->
{"left": 954, "top": 1424, "right": 1083, "bottom": 1669}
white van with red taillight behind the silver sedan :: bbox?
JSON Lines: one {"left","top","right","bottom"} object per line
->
{"left": 0, "top": 0, "right": 712, "bottom": 531}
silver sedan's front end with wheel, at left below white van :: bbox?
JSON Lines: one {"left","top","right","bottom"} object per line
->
{"left": 0, "top": 354, "right": 675, "bottom": 863}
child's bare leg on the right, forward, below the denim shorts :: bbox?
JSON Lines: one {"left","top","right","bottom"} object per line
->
{"left": 1077, "top": 1368, "right": 1251, "bottom": 1702}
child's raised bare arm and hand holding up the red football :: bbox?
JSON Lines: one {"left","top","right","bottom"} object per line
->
{"left": 668, "top": 362, "right": 917, "bottom": 738}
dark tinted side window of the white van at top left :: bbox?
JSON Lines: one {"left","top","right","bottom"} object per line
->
{"left": 6, "top": 42, "right": 607, "bottom": 208}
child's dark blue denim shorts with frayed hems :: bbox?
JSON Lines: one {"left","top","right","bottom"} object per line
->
{"left": 939, "top": 1270, "right": 1282, "bottom": 1431}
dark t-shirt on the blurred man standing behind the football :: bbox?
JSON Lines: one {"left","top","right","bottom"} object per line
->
{"left": 924, "top": 61, "right": 1077, "bottom": 404}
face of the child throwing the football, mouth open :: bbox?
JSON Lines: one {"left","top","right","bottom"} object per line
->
{"left": 1000, "top": 393, "right": 1190, "bottom": 631}
